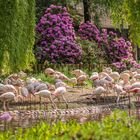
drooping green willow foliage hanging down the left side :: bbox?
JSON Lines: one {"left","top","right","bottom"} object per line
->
{"left": 0, "top": 0, "right": 35, "bottom": 73}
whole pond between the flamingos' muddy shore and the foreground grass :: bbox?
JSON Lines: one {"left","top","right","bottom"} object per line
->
{"left": 0, "top": 95, "right": 139, "bottom": 131}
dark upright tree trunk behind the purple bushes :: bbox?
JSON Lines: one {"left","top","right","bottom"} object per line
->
{"left": 83, "top": 0, "right": 91, "bottom": 22}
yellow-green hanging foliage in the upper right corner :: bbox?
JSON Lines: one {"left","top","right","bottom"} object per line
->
{"left": 96, "top": 0, "right": 140, "bottom": 46}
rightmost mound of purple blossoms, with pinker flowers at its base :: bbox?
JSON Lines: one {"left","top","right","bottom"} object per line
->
{"left": 107, "top": 32, "right": 140, "bottom": 70}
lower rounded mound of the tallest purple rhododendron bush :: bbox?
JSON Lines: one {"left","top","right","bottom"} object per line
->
{"left": 37, "top": 38, "right": 82, "bottom": 64}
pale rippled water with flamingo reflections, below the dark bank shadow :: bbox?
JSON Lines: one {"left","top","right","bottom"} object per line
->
{"left": 0, "top": 100, "right": 140, "bottom": 131}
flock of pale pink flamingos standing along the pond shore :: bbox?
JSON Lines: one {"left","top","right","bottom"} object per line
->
{"left": 0, "top": 67, "right": 140, "bottom": 111}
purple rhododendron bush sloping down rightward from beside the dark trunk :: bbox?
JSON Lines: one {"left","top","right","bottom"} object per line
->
{"left": 78, "top": 22, "right": 140, "bottom": 70}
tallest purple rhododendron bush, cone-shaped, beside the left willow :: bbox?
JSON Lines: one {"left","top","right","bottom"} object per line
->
{"left": 35, "top": 5, "right": 82, "bottom": 63}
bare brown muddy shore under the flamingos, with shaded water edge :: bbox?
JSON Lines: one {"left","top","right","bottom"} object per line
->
{"left": 1, "top": 88, "right": 131, "bottom": 110}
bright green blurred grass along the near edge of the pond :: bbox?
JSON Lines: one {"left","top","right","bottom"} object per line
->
{"left": 0, "top": 111, "right": 140, "bottom": 140}
